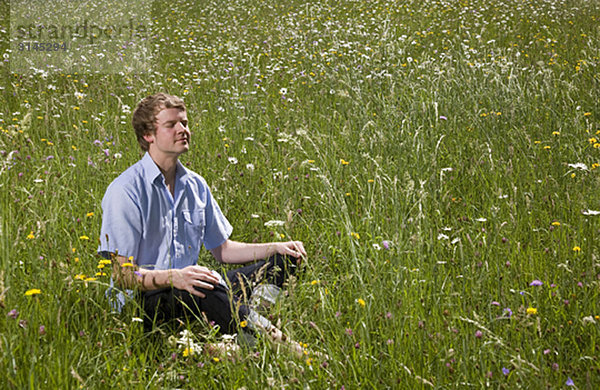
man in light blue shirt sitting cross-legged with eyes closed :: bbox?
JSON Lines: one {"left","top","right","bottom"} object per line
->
{"left": 98, "top": 93, "right": 306, "bottom": 355}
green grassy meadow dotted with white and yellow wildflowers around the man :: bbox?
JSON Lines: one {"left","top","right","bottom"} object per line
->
{"left": 0, "top": 0, "right": 600, "bottom": 389}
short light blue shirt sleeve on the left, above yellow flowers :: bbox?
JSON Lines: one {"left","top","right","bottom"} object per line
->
{"left": 98, "top": 183, "right": 143, "bottom": 259}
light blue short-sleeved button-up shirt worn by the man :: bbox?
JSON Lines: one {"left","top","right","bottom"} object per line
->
{"left": 98, "top": 153, "right": 233, "bottom": 269}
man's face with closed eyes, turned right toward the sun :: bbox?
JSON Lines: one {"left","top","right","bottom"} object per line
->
{"left": 144, "top": 108, "right": 191, "bottom": 158}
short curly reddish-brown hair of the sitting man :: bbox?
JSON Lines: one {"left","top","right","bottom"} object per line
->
{"left": 131, "top": 92, "right": 186, "bottom": 152}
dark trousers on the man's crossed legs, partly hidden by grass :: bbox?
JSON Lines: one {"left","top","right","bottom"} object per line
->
{"left": 141, "top": 255, "right": 297, "bottom": 334}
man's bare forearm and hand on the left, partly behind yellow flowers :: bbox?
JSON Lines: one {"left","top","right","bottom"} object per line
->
{"left": 112, "top": 256, "right": 219, "bottom": 298}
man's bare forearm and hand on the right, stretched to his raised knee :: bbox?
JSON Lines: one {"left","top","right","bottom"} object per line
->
{"left": 210, "top": 240, "right": 306, "bottom": 264}
